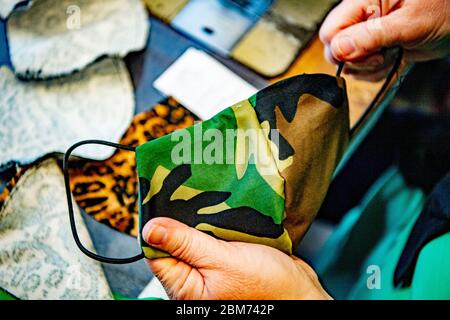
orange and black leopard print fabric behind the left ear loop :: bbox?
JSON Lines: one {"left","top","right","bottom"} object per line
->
{"left": 69, "top": 98, "right": 198, "bottom": 236}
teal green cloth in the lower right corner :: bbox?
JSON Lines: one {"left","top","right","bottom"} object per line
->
{"left": 315, "top": 167, "right": 450, "bottom": 299}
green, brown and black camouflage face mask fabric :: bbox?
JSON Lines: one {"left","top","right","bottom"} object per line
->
{"left": 136, "top": 74, "right": 349, "bottom": 258}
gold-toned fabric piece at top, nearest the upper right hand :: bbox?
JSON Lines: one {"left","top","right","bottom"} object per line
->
{"left": 231, "top": 0, "right": 337, "bottom": 77}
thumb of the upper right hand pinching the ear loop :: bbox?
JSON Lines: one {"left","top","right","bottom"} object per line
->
{"left": 330, "top": 10, "right": 402, "bottom": 61}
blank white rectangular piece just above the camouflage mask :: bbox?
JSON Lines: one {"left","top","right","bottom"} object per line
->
{"left": 153, "top": 48, "right": 257, "bottom": 120}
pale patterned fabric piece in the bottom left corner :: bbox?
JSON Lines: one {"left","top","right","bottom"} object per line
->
{"left": 0, "top": 159, "right": 112, "bottom": 299}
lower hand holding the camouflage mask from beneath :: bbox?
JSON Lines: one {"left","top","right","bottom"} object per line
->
{"left": 142, "top": 218, "right": 330, "bottom": 300}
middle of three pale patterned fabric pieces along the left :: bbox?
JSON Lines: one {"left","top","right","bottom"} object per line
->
{"left": 0, "top": 59, "right": 134, "bottom": 169}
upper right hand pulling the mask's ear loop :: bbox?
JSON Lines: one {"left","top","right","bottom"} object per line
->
{"left": 320, "top": 0, "right": 450, "bottom": 81}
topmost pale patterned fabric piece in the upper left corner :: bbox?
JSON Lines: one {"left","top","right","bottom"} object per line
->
{"left": 7, "top": 0, "right": 150, "bottom": 79}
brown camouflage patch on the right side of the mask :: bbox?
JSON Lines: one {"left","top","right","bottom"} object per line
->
{"left": 275, "top": 78, "right": 349, "bottom": 242}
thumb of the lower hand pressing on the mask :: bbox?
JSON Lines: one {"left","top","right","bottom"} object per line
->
{"left": 142, "top": 218, "right": 228, "bottom": 268}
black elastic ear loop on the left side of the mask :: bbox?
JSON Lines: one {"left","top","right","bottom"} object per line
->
{"left": 63, "top": 140, "right": 144, "bottom": 264}
